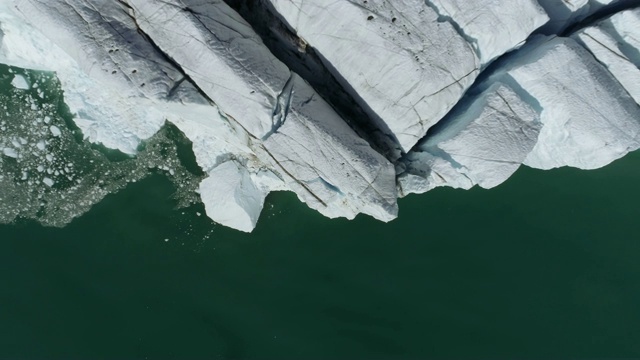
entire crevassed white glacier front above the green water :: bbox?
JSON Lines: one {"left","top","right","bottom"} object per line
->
{"left": 0, "top": 0, "right": 640, "bottom": 232}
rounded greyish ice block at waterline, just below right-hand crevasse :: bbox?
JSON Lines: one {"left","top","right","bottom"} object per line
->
{"left": 398, "top": 82, "right": 542, "bottom": 196}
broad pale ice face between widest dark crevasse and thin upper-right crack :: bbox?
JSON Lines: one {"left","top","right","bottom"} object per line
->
{"left": 271, "top": 0, "right": 481, "bottom": 151}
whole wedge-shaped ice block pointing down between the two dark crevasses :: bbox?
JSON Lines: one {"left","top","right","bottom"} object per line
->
{"left": 269, "top": 0, "right": 547, "bottom": 152}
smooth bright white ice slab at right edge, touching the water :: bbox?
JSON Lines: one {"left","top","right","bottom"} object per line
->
{"left": 493, "top": 37, "right": 640, "bottom": 169}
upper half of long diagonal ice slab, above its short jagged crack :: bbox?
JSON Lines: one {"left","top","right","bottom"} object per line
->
{"left": 130, "top": 0, "right": 290, "bottom": 138}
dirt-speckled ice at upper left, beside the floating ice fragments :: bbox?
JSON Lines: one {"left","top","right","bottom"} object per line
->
{"left": 0, "top": 0, "right": 225, "bottom": 154}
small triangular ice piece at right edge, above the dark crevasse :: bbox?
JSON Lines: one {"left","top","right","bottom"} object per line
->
{"left": 573, "top": 8, "right": 640, "bottom": 104}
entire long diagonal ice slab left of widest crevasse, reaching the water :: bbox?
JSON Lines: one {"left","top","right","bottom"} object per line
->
{"left": 125, "top": 0, "right": 397, "bottom": 224}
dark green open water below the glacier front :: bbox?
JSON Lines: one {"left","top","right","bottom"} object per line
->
{"left": 0, "top": 153, "right": 640, "bottom": 359}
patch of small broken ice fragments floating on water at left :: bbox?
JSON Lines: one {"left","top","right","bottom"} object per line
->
{"left": 0, "top": 66, "right": 201, "bottom": 226}
